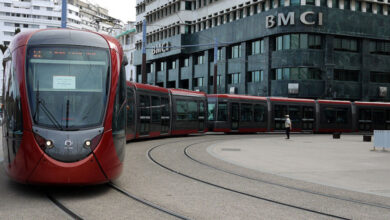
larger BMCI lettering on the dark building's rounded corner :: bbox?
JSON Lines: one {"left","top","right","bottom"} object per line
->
{"left": 265, "top": 11, "right": 323, "bottom": 28}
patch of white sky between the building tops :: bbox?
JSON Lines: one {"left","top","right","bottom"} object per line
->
{"left": 88, "top": 0, "right": 136, "bottom": 23}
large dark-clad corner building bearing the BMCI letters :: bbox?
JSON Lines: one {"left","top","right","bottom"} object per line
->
{"left": 134, "top": 0, "right": 390, "bottom": 101}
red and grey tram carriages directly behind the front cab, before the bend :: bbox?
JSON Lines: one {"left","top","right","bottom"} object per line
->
{"left": 126, "top": 82, "right": 207, "bottom": 140}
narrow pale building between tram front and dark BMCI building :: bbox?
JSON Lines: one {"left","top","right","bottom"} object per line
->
{"left": 115, "top": 21, "right": 136, "bottom": 81}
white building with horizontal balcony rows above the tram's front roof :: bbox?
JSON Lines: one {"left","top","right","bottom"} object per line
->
{"left": 0, "top": 0, "right": 81, "bottom": 45}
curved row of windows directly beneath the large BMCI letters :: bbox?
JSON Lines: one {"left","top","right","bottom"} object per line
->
{"left": 276, "top": 34, "right": 321, "bottom": 50}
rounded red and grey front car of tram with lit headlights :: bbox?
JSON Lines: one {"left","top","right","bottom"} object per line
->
{"left": 2, "top": 29, "right": 126, "bottom": 184}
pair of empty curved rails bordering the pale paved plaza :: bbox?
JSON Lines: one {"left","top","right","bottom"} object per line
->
{"left": 147, "top": 138, "right": 390, "bottom": 219}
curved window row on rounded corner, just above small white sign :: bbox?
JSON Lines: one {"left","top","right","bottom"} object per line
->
{"left": 272, "top": 67, "right": 321, "bottom": 80}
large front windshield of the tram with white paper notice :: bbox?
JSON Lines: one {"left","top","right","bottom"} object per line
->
{"left": 26, "top": 46, "right": 110, "bottom": 130}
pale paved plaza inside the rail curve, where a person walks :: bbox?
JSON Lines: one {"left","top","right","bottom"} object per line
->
{"left": 208, "top": 134, "right": 390, "bottom": 197}
